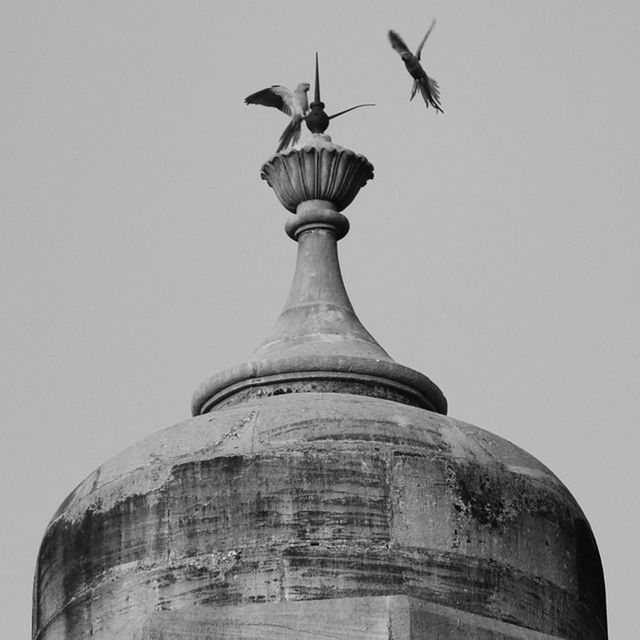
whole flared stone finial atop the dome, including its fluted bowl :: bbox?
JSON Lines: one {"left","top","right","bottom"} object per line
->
{"left": 192, "top": 134, "right": 447, "bottom": 415}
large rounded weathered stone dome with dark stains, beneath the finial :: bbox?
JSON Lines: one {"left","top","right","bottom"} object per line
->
{"left": 34, "top": 393, "right": 606, "bottom": 640}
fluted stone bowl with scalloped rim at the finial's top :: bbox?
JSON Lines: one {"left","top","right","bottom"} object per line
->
{"left": 260, "top": 134, "right": 373, "bottom": 213}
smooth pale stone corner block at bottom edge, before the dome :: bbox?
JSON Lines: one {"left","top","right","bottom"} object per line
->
{"left": 134, "top": 596, "right": 558, "bottom": 640}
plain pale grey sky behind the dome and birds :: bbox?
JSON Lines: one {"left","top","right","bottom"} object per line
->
{"left": 0, "top": 0, "right": 640, "bottom": 638}
